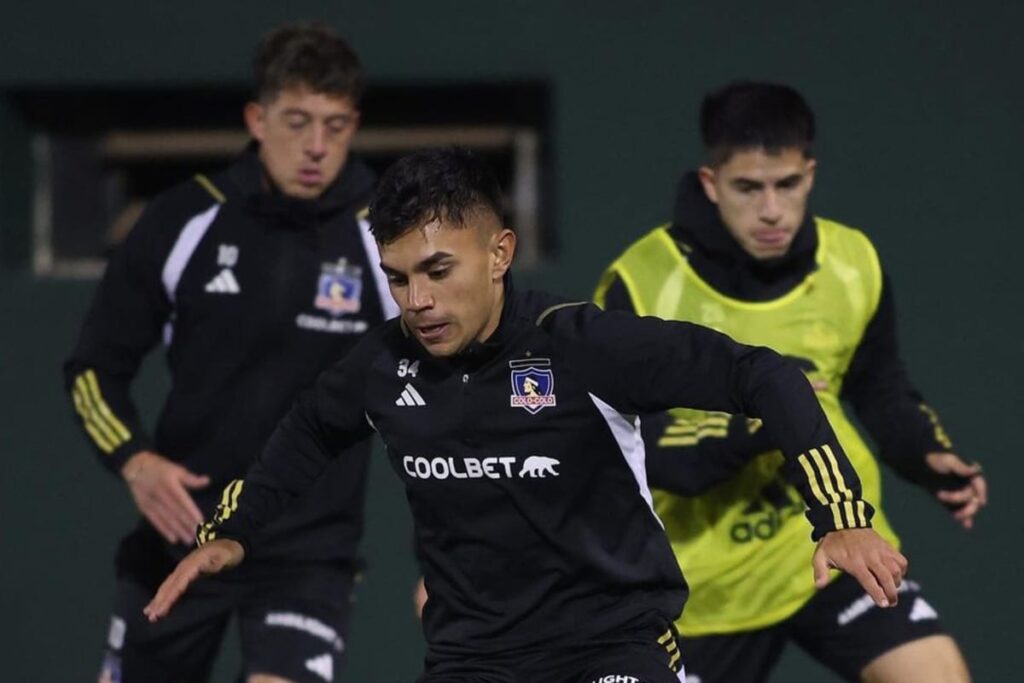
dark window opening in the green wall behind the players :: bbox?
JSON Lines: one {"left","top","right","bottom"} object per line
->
{"left": 6, "top": 82, "right": 557, "bottom": 276}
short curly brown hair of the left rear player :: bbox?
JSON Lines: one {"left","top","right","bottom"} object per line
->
{"left": 253, "top": 23, "right": 366, "bottom": 104}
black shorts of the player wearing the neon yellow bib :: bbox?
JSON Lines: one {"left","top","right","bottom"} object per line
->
{"left": 680, "top": 574, "right": 946, "bottom": 683}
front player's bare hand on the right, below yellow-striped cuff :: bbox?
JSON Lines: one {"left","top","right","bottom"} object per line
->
{"left": 811, "top": 528, "right": 907, "bottom": 607}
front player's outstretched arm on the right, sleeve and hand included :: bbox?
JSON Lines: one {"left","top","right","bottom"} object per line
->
{"left": 538, "top": 305, "right": 907, "bottom": 606}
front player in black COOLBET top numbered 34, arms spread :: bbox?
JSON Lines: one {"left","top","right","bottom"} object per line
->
{"left": 145, "top": 150, "right": 905, "bottom": 683}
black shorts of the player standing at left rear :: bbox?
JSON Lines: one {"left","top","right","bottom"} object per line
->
{"left": 99, "top": 536, "right": 353, "bottom": 683}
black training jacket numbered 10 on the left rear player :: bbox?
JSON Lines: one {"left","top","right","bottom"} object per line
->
{"left": 65, "top": 144, "right": 397, "bottom": 561}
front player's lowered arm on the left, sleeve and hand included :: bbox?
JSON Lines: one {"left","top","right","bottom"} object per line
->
{"left": 143, "top": 333, "right": 387, "bottom": 622}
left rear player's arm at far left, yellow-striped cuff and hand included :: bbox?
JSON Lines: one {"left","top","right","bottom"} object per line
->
{"left": 63, "top": 196, "right": 208, "bottom": 544}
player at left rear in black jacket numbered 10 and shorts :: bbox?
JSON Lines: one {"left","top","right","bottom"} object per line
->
{"left": 65, "top": 25, "right": 397, "bottom": 683}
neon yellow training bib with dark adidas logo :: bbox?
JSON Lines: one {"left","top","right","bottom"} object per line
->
{"left": 595, "top": 218, "right": 899, "bottom": 636}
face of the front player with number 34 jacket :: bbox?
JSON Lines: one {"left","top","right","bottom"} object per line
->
{"left": 380, "top": 209, "right": 515, "bottom": 356}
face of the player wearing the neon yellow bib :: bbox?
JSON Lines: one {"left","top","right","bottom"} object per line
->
{"left": 699, "top": 147, "right": 815, "bottom": 259}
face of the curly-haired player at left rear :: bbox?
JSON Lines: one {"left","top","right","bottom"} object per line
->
{"left": 245, "top": 86, "right": 359, "bottom": 200}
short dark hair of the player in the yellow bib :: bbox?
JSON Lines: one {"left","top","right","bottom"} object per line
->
{"left": 700, "top": 81, "right": 814, "bottom": 165}
